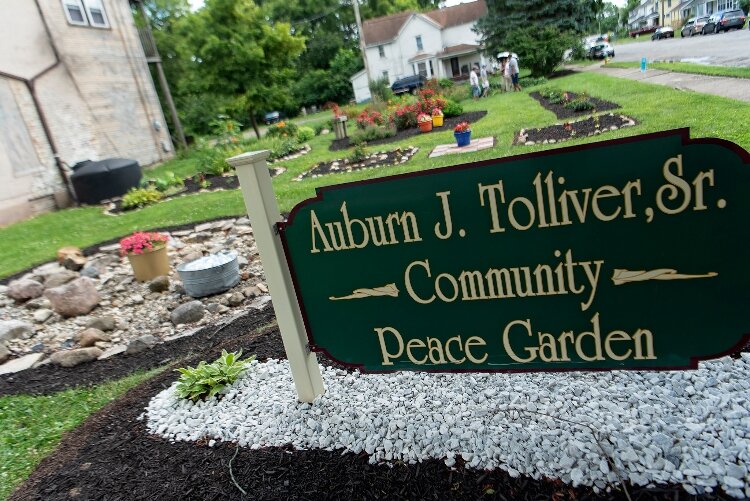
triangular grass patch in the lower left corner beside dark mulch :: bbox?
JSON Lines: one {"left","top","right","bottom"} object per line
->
{"left": 0, "top": 369, "right": 162, "bottom": 500}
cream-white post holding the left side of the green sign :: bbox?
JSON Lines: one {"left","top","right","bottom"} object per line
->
{"left": 227, "top": 150, "right": 325, "bottom": 402}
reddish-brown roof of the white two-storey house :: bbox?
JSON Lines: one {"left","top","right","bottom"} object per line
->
{"left": 362, "top": 0, "right": 487, "bottom": 45}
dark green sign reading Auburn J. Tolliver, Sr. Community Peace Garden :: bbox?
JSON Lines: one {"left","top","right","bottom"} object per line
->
{"left": 279, "top": 129, "right": 750, "bottom": 371}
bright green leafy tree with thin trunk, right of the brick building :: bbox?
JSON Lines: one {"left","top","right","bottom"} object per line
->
{"left": 189, "top": 0, "right": 305, "bottom": 137}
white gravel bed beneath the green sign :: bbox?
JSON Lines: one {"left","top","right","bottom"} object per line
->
{"left": 146, "top": 353, "right": 750, "bottom": 498}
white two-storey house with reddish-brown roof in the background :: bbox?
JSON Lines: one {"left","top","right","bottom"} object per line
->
{"left": 351, "top": 0, "right": 487, "bottom": 102}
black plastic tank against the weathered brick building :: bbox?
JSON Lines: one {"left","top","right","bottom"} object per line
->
{"left": 70, "top": 158, "right": 141, "bottom": 204}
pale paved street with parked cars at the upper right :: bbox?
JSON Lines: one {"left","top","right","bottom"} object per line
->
{"left": 614, "top": 28, "right": 750, "bottom": 66}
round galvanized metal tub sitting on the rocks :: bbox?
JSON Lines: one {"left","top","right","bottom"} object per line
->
{"left": 177, "top": 252, "right": 240, "bottom": 297}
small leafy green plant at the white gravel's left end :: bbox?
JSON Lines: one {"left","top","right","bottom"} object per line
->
{"left": 175, "top": 350, "right": 255, "bottom": 402}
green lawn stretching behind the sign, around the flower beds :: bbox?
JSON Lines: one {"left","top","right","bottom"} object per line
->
{"left": 0, "top": 73, "right": 750, "bottom": 277}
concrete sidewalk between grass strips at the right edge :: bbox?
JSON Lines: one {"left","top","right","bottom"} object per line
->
{"left": 574, "top": 65, "right": 750, "bottom": 102}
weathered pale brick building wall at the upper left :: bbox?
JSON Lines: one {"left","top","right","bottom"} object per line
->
{"left": 0, "top": 0, "right": 173, "bottom": 225}
